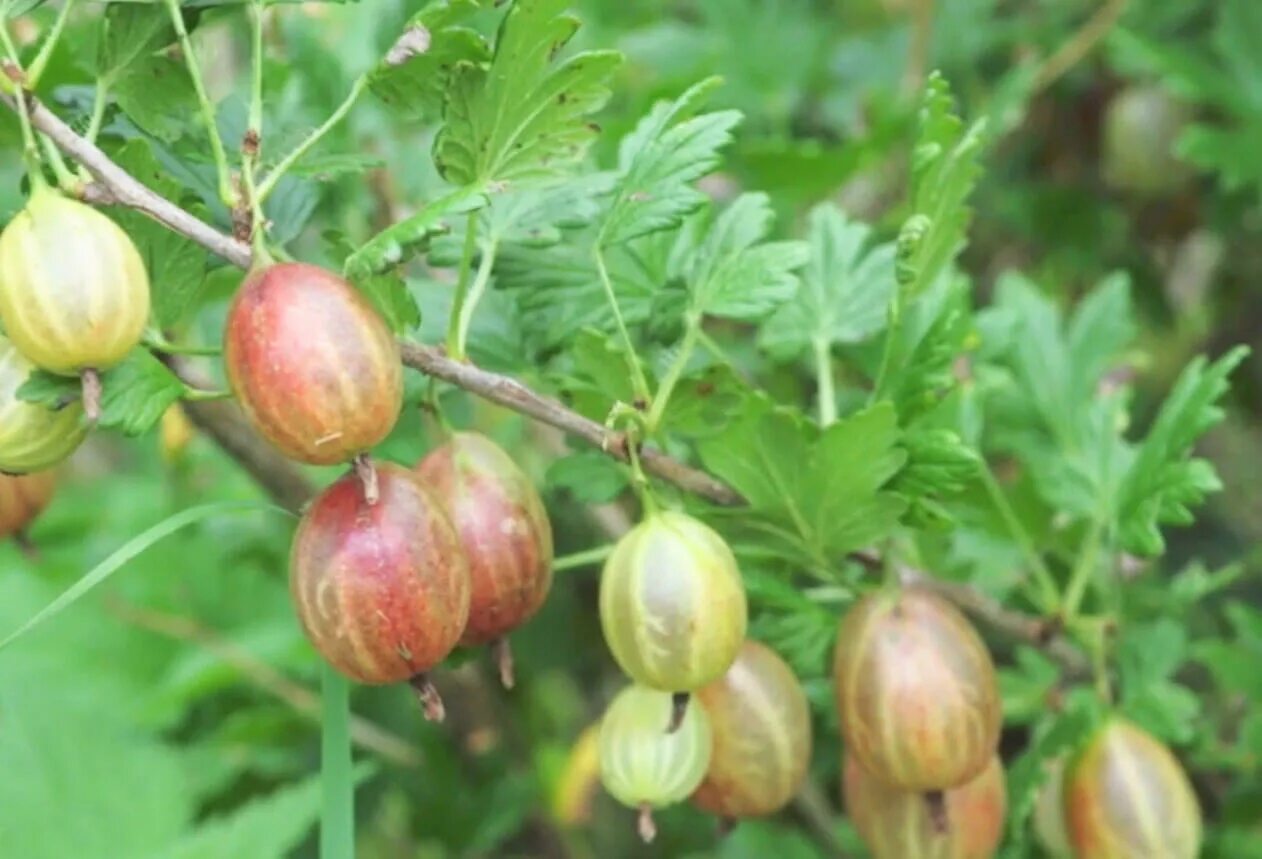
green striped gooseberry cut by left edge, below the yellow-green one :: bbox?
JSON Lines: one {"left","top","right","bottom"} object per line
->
{"left": 0, "top": 337, "right": 87, "bottom": 474}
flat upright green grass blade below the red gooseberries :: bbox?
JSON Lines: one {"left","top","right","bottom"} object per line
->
{"left": 319, "top": 665, "right": 355, "bottom": 859}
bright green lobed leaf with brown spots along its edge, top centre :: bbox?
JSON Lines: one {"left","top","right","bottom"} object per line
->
{"left": 434, "top": 0, "right": 622, "bottom": 187}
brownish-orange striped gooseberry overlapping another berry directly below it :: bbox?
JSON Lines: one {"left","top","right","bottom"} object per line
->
{"left": 833, "top": 588, "right": 1002, "bottom": 791}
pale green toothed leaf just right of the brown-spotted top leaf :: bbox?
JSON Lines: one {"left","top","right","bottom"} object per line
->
{"left": 597, "top": 78, "right": 741, "bottom": 246}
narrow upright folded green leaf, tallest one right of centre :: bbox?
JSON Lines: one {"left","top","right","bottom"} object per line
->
{"left": 896, "top": 72, "right": 986, "bottom": 305}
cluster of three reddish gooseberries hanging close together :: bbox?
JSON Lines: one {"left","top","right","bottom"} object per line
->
{"left": 223, "top": 262, "right": 553, "bottom": 720}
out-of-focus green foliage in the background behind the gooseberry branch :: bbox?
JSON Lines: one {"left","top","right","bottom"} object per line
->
{"left": 0, "top": 0, "right": 1262, "bottom": 859}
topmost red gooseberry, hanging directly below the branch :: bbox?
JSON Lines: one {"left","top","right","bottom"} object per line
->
{"left": 223, "top": 262, "right": 403, "bottom": 465}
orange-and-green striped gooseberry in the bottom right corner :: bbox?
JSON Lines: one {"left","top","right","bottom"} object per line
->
{"left": 1064, "top": 716, "right": 1201, "bottom": 859}
